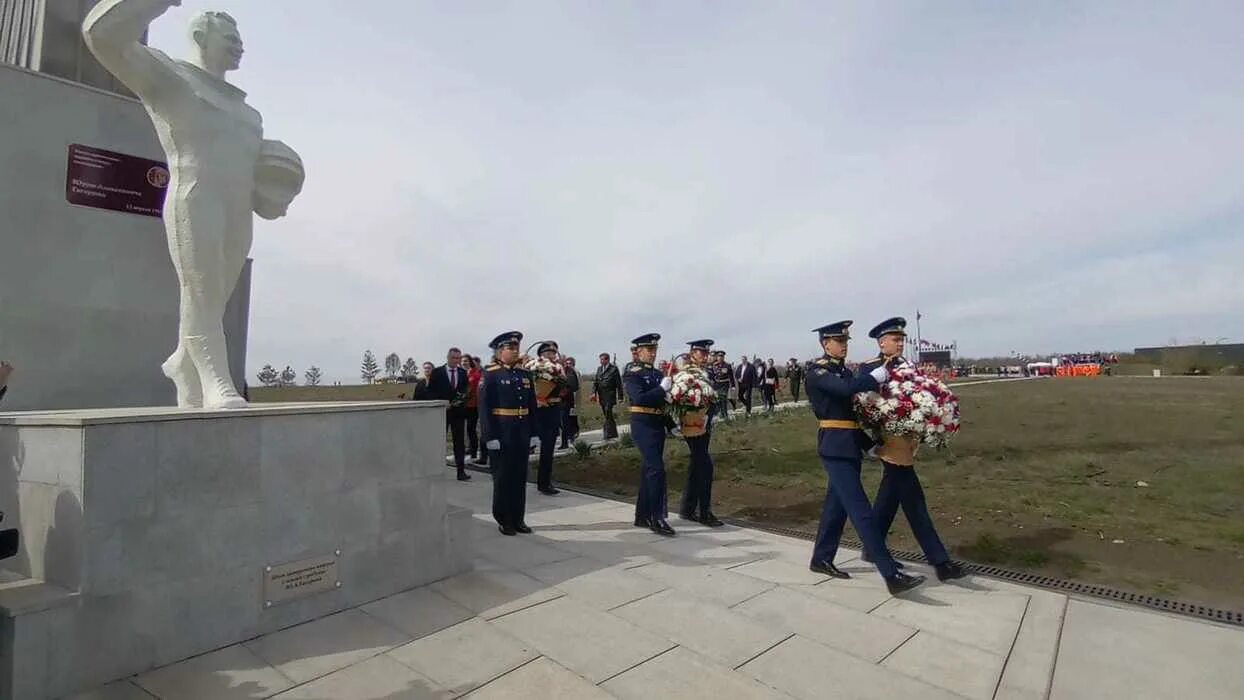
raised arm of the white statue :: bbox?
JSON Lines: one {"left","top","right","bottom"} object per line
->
{"left": 82, "top": 0, "right": 182, "bottom": 97}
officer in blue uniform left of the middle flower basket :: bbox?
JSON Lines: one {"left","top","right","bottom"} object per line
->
{"left": 622, "top": 333, "right": 674, "bottom": 537}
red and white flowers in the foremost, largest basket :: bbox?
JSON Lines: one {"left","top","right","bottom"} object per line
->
{"left": 855, "top": 366, "right": 959, "bottom": 448}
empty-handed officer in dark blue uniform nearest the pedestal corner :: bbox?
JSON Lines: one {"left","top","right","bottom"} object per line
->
{"left": 479, "top": 331, "right": 536, "bottom": 535}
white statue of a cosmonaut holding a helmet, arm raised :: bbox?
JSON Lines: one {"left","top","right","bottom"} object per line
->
{"left": 82, "top": 0, "right": 304, "bottom": 408}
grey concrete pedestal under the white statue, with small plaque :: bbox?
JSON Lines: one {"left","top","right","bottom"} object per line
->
{"left": 0, "top": 402, "right": 473, "bottom": 699}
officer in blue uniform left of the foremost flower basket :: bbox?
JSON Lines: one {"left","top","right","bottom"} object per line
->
{"left": 806, "top": 321, "right": 924, "bottom": 596}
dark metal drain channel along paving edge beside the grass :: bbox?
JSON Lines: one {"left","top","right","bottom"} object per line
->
{"left": 557, "top": 484, "right": 1244, "bottom": 627}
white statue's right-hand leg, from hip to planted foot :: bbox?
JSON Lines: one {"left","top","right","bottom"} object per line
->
{"left": 169, "top": 191, "right": 246, "bottom": 408}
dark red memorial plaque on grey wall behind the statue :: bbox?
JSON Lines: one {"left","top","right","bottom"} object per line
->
{"left": 65, "top": 143, "right": 169, "bottom": 216}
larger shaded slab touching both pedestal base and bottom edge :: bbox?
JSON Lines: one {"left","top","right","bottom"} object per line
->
{"left": 134, "top": 644, "right": 295, "bottom": 700}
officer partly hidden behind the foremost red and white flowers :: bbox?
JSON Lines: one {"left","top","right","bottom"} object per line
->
{"left": 860, "top": 316, "right": 967, "bottom": 581}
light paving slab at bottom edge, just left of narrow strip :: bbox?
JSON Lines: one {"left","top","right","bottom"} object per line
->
{"left": 881, "top": 630, "right": 1006, "bottom": 700}
